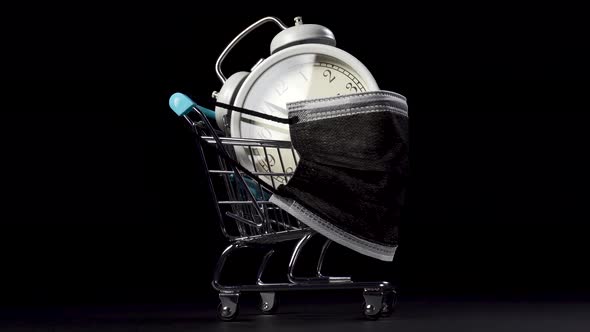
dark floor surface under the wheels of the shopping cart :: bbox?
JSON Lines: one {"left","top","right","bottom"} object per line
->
{"left": 0, "top": 300, "right": 590, "bottom": 332}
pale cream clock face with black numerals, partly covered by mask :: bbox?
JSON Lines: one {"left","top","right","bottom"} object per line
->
{"left": 231, "top": 50, "right": 377, "bottom": 187}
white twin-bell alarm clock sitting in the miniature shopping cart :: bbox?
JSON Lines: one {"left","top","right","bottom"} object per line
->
{"left": 213, "top": 17, "right": 379, "bottom": 186}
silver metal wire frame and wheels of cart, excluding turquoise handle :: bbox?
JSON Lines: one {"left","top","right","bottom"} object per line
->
{"left": 181, "top": 104, "right": 396, "bottom": 321}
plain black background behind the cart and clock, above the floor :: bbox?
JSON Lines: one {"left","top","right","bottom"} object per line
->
{"left": 0, "top": 3, "right": 590, "bottom": 306}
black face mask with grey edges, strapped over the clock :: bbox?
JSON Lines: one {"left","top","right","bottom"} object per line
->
{"left": 171, "top": 91, "right": 409, "bottom": 261}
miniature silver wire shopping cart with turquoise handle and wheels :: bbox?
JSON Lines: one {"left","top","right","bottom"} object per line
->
{"left": 170, "top": 93, "right": 396, "bottom": 321}
